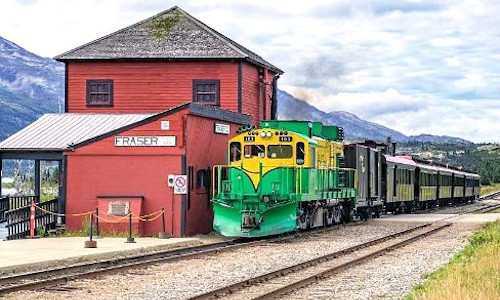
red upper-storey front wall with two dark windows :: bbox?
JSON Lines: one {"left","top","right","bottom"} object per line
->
{"left": 68, "top": 62, "right": 238, "bottom": 112}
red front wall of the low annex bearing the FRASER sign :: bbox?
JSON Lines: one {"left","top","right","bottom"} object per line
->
{"left": 66, "top": 110, "right": 187, "bottom": 236}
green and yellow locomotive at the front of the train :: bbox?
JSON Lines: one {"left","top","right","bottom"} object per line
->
{"left": 212, "top": 121, "right": 357, "bottom": 237}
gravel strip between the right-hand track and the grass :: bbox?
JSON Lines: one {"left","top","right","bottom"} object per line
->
{"left": 286, "top": 224, "right": 479, "bottom": 300}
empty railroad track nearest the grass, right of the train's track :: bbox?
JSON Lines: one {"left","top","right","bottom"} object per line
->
{"left": 190, "top": 223, "right": 451, "bottom": 300}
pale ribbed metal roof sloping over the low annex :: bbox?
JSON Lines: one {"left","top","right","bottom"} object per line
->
{"left": 0, "top": 113, "right": 154, "bottom": 151}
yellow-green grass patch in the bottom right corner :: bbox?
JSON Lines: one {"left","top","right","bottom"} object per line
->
{"left": 404, "top": 221, "right": 500, "bottom": 300}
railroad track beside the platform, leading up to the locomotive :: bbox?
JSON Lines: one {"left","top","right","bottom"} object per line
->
{"left": 0, "top": 226, "right": 346, "bottom": 295}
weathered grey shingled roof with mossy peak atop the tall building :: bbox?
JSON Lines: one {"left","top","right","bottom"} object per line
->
{"left": 55, "top": 6, "right": 283, "bottom": 73}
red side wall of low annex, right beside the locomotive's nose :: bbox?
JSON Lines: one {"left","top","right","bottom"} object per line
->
{"left": 186, "top": 116, "right": 240, "bottom": 235}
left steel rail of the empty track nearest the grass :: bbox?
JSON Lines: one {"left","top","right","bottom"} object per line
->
{"left": 189, "top": 223, "right": 434, "bottom": 300}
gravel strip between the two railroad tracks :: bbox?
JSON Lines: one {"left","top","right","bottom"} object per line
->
{"left": 8, "top": 223, "right": 422, "bottom": 299}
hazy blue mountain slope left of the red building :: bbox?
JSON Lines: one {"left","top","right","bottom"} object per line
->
{"left": 0, "top": 37, "right": 64, "bottom": 141}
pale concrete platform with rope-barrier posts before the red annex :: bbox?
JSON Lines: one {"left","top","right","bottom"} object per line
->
{"left": 0, "top": 237, "right": 202, "bottom": 276}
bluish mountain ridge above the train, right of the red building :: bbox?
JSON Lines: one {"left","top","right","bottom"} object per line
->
{"left": 278, "top": 90, "right": 407, "bottom": 142}
